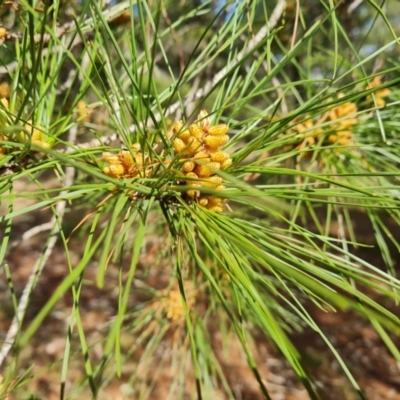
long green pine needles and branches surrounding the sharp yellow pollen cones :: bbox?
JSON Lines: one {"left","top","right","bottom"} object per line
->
{"left": 0, "top": 0, "right": 400, "bottom": 399}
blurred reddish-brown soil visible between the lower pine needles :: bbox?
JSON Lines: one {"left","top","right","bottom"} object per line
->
{"left": 0, "top": 203, "right": 400, "bottom": 400}
